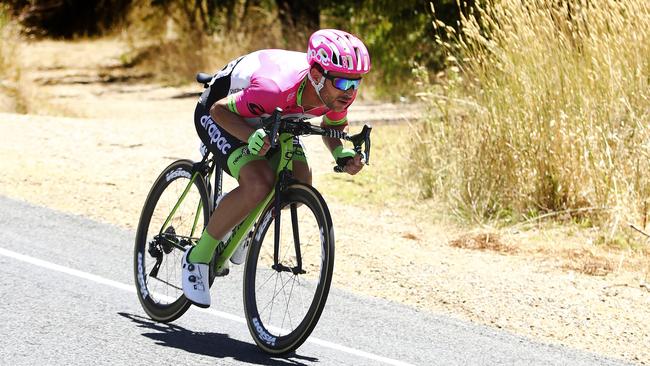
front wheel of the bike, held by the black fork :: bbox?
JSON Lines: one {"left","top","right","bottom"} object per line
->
{"left": 244, "top": 184, "right": 334, "bottom": 355}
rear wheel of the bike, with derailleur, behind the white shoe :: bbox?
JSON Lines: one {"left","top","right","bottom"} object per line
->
{"left": 134, "top": 160, "right": 210, "bottom": 322}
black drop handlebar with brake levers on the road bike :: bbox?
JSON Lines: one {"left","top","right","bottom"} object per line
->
{"left": 244, "top": 107, "right": 372, "bottom": 173}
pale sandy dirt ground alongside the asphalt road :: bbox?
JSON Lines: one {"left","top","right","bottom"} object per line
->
{"left": 0, "top": 40, "right": 650, "bottom": 364}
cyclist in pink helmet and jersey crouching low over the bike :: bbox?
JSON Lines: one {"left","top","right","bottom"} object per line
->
{"left": 181, "top": 29, "right": 370, "bottom": 307}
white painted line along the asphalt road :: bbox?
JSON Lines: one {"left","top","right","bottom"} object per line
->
{"left": 0, "top": 248, "right": 412, "bottom": 366}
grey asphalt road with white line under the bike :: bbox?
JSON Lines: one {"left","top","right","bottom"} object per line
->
{"left": 0, "top": 197, "right": 625, "bottom": 365}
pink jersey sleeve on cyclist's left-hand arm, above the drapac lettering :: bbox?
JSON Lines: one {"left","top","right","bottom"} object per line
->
{"left": 227, "top": 78, "right": 282, "bottom": 118}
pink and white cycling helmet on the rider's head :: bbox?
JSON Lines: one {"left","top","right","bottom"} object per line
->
{"left": 307, "top": 29, "right": 370, "bottom": 74}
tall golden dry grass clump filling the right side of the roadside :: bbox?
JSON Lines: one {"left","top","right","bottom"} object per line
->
{"left": 412, "top": 0, "right": 650, "bottom": 247}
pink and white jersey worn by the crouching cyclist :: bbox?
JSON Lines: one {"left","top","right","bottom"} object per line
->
{"left": 221, "top": 50, "right": 352, "bottom": 128}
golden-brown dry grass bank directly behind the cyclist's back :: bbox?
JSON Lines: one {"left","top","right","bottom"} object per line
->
{"left": 122, "top": 0, "right": 294, "bottom": 85}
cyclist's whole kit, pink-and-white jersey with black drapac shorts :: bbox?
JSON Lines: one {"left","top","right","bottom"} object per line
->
{"left": 194, "top": 50, "right": 356, "bottom": 178}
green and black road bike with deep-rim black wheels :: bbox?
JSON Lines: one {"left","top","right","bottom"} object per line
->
{"left": 134, "top": 74, "right": 372, "bottom": 355}
